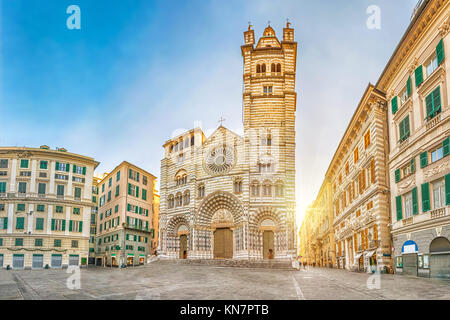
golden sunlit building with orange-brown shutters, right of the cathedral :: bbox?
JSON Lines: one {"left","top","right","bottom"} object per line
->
{"left": 326, "top": 84, "right": 392, "bottom": 272}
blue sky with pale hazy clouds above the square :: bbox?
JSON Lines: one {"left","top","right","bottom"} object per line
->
{"left": 0, "top": 0, "right": 417, "bottom": 225}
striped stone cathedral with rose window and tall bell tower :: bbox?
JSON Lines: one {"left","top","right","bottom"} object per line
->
{"left": 159, "top": 23, "right": 297, "bottom": 260}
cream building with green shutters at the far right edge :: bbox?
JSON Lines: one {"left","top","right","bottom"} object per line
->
{"left": 377, "top": 0, "right": 450, "bottom": 278}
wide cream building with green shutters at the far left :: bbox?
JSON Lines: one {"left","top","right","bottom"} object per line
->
{"left": 0, "top": 146, "right": 99, "bottom": 269}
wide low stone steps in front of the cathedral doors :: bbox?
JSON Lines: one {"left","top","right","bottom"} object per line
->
{"left": 155, "top": 258, "right": 295, "bottom": 270}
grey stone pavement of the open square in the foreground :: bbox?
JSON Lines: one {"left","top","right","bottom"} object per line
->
{"left": 0, "top": 262, "right": 450, "bottom": 300}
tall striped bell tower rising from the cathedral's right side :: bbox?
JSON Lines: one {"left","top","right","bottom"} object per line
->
{"left": 241, "top": 22, "right": 297, "bottom": 255}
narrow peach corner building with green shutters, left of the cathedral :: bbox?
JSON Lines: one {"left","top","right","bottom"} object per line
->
{"left": 96, "top": 161, "right": 156, "bottom": 267}
